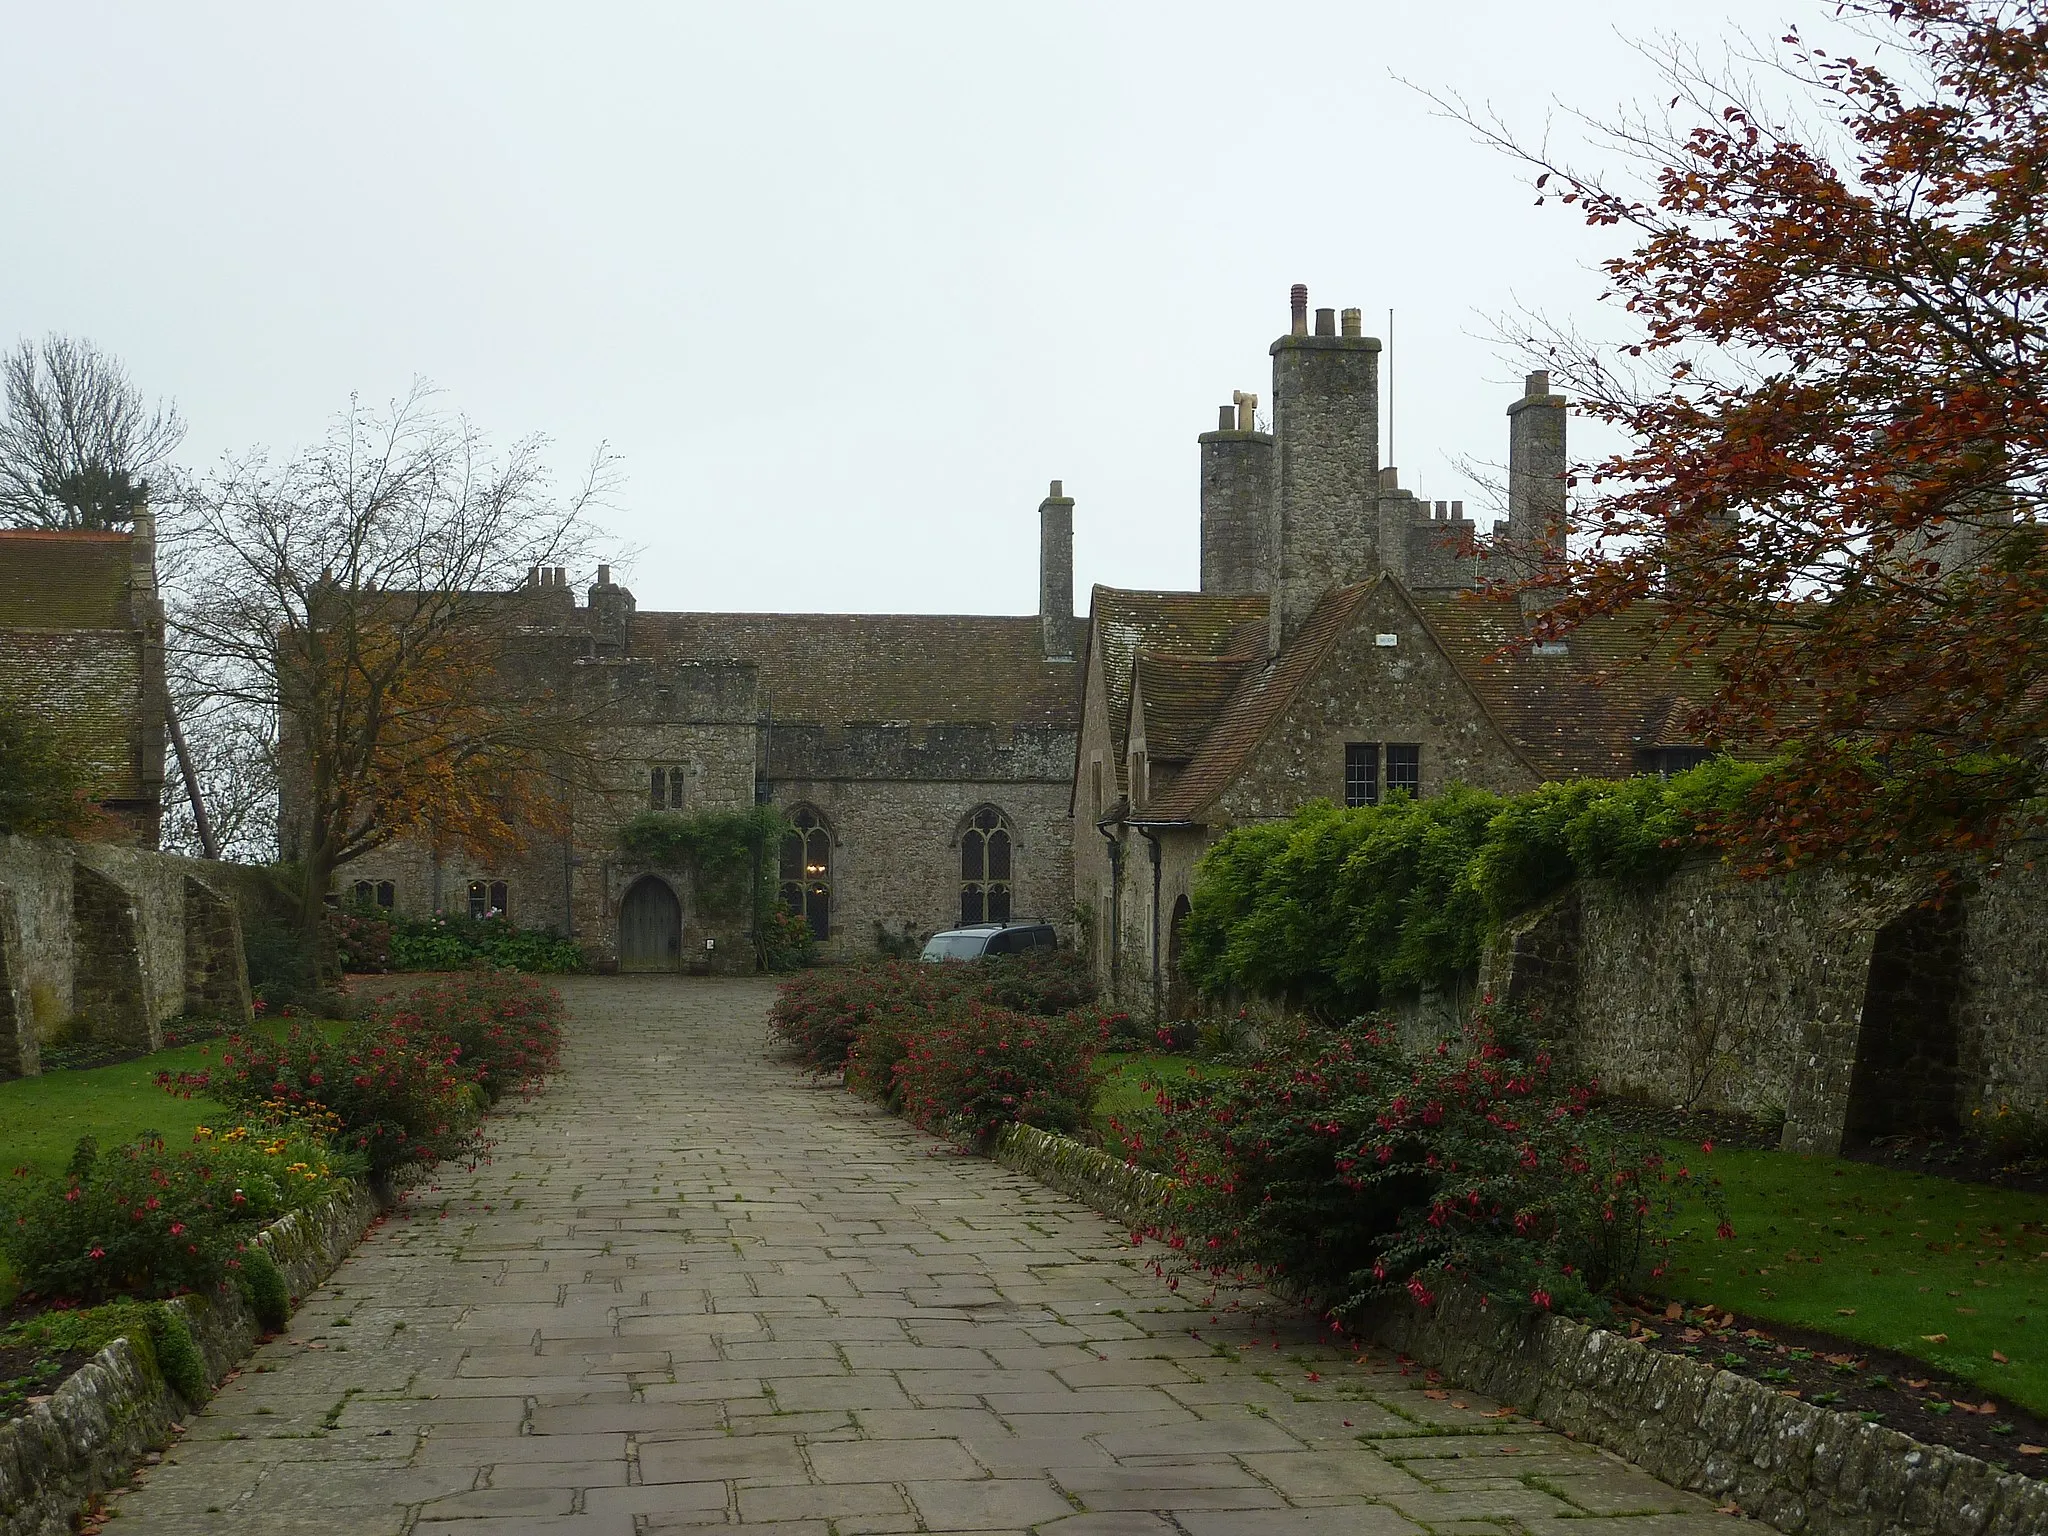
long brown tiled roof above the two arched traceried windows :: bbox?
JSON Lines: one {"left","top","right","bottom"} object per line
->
{"left": 631, "top": 610, "right": 1081, "bottom": 729}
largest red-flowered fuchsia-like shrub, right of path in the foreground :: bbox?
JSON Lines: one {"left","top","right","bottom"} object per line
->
{"left": 1133, "top": 1014, "right": 1726, "bottom": 1323}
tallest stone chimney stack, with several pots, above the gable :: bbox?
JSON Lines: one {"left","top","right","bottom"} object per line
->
{"left": 1266, "top": 283, "right": 1380, "bottom": 651}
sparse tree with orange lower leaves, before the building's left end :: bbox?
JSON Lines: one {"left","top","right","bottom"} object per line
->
{"left": 170, "top": 387, "right": 608, "bottom": 928}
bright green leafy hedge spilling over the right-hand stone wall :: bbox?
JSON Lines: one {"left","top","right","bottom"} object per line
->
{"left": 1184, "top": 758, "right": 1763, "bottom": 1014}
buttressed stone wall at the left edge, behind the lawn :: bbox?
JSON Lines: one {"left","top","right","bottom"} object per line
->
{"left": 0, "top": 836, "right": 256, "bottom": 1077}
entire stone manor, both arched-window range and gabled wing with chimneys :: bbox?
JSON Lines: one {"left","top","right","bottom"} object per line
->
{"left": 342, "top": 287, "right": 1702, "bottom": 987}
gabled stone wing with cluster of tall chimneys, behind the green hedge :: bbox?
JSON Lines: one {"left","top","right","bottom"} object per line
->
{"left": 1071, "top": 285, "right": 1708, "bottom": 1012}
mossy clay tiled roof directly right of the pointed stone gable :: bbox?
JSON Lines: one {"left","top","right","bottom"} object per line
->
{"left": 1411, "top": 592, "right": 1714, "bottom": 778}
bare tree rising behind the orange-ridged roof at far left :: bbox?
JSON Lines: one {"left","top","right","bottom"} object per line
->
{"left": 0, "top": 334, "right": 184, "bottom": 528}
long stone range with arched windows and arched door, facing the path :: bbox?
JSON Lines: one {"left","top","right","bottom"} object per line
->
{"left": 340, "top": 512, "right": 1079, "bottom": 971}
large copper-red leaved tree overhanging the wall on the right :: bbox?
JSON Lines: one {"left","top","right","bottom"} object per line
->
{"left": 1452, "top": 0, "right": 2048, "bottom": 872}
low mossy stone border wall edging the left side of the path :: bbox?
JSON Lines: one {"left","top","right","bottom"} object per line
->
{"left": 0, "top": 1182, "right": 377, "bottom": 1536}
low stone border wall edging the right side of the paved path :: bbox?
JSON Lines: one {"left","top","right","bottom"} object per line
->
{"left": 993, "top": 1126, "right": 2048, "bottom": 1536}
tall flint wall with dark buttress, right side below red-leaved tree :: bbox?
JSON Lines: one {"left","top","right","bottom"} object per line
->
{"left": 1481, "top": 864, "right": 2048, "bottom": 1153}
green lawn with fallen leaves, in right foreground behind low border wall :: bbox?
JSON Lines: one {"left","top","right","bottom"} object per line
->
{"left": 1663, "top": 1145, "right": 2048, "bottom": 1413}
